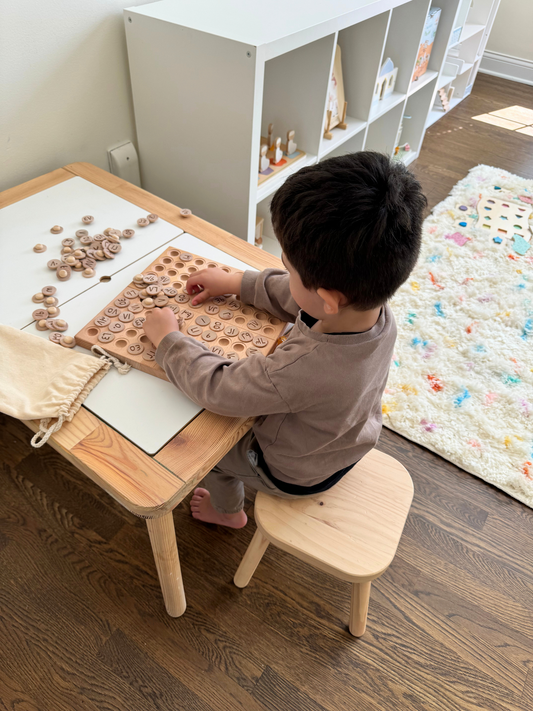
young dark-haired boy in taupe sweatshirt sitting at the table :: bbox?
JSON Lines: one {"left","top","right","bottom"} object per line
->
{"left": 144, "top": 151, "right": 426, "bottom": 528}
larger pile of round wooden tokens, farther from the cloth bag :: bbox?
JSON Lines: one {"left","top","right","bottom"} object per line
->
{"left": 38, "top": 213, "right": 158, "bottom": 281}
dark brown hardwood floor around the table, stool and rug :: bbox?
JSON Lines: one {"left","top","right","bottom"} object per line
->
{"left": 0, "top": 75, "right": 533, "bottom": 711}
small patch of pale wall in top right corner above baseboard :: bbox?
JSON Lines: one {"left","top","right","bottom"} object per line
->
{"left": 487, "top": 0, "right": 533, "bottom": 61}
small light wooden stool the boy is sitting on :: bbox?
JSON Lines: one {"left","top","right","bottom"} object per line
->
{"left": 234, "top": 449, "right": 413, "bottom": 637}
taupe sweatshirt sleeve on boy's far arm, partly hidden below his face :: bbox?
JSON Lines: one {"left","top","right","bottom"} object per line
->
{"left": 241, "top": 269, "right": 300, "bottom": 321}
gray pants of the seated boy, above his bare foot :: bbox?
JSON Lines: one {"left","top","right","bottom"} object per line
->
{"left": 203, "top": 430, "right": 310, "bottom": 514}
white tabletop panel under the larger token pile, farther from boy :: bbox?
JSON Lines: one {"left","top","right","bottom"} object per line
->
{"left": 0, "top": 177, "right": 183, "bottom": 328}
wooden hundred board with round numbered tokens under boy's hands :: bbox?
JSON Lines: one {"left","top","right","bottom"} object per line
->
{"left": 76, "top": 247, "right": 285, "bottom": 380}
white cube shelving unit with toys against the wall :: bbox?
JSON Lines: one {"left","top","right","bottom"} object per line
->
{"left": 124, "top": 0, "right": 499, "bottom": 250}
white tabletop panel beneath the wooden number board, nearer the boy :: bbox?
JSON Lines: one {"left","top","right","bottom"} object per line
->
{"left": 24, "top": 233, "right": 253, "bottom": 454}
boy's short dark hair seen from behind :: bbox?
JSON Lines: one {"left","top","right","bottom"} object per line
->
{"left": 270, "top": 151, "right": 427, "bottom": 311}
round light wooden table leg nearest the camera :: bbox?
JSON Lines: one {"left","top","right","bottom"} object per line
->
{"left": 146, "top": 511, "right": 187, "bottom": 617}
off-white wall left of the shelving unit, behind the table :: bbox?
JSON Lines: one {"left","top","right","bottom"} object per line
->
{"left": 0, "top": 0, "right": 156, "bottom": 190}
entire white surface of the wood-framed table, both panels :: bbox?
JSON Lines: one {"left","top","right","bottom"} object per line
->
{"left": 0, "top": 178, "right": 253, "bottom": 454}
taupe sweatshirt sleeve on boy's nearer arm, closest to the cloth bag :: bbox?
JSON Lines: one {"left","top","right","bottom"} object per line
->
{"left": 155, "top": 331, "right": 290, "bottom": 417}
